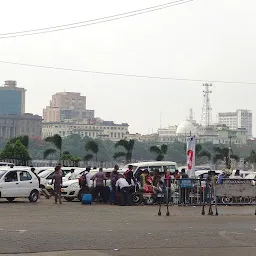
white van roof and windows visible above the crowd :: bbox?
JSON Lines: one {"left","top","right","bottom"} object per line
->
{"left": 123, "top": 161, "right": 178, "bottom": 175}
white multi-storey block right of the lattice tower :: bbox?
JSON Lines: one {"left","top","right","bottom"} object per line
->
{"left": 218, "top": 109, "right": 252, "bottom": 138}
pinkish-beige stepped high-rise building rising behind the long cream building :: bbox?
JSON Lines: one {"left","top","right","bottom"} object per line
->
{"left": 43, "top": 92, "right": 94, "bottom": 122}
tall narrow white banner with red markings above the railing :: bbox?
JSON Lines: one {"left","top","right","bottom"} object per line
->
{"left": 187, "top": 136, "right": 196, "bottom": 178}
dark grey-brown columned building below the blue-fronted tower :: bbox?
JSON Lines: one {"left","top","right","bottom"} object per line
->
{"left": 0, "top": 114, "right": 42, "bottom": 139}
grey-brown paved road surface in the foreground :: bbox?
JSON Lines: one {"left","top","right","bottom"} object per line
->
{"left": 0, "top": 200, "right": 256, "bottom": 256}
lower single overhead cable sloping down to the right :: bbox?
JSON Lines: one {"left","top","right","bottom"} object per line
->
{"left": 0, "top": 60, "right": 256, "bottom": 85}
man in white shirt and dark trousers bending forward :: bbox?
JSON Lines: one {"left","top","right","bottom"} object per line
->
{"left": 116, "top": 175, "right": 134, "bottom": 206}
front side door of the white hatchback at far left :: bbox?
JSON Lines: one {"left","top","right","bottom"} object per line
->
{"left": 2, "top": 171, "right": 19, "bottom": 197}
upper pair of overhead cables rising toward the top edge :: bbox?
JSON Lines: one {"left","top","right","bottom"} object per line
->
{"left": 0, "top": 0, "right": 194, "bottom": 39}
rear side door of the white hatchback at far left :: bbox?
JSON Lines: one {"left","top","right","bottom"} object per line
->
{"left": 18, "top": 171, "right": 34, "bottom": 197}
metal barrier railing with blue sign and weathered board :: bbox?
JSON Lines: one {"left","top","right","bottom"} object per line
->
{"left": 162, "top": 179, "right": 256, "bottom": 206}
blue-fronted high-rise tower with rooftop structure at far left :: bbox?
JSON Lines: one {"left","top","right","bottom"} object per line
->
{"left": 0, "top": 80, "right": 26, "bottom": 115}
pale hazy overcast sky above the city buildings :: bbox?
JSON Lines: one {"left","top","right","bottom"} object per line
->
{"left": 0, "top": 0, "right": 256, "bottom": 135}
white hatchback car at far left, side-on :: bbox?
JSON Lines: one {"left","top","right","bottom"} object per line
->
{"left": 0, "top": 167, "right": 39, "bottom": 202}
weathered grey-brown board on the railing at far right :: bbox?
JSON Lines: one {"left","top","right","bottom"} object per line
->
{"left": 215, "top": 179, "right": 256, "bottom": 197}
